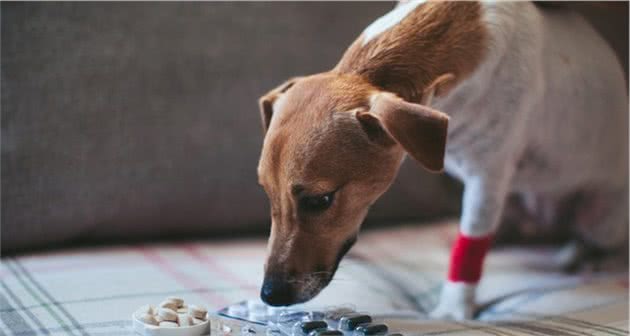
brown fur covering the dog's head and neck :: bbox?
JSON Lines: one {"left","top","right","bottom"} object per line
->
{"left": 258, "top": 2, "right": 486, "bottom": 303}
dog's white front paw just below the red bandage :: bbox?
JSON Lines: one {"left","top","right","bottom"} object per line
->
{"left": 429, "top": 281, "right": 477, "bottom": 321}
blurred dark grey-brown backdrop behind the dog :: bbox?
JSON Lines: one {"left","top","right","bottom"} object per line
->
{"left": 1, "top": 2, "right": 628, "bottom": 252}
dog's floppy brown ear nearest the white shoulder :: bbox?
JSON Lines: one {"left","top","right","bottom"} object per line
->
{"left": 355, "top": 92, "right": 449, "bottom": 172}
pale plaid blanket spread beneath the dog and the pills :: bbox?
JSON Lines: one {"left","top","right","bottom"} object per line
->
{"left": 0, "top": 223, "right": 628, "bottom": 336}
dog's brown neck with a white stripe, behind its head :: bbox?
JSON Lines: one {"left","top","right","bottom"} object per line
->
{"left": 333, "top": 2, "right": 487, "bottom": 103}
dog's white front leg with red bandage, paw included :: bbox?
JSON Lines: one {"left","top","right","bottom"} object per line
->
{"left": 431, "top": 168, "right": 512, "bottom": 320}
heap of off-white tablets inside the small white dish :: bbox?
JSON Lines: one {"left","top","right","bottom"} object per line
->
{"left": 133, "top": 296, "right": 208, "bottom": 328}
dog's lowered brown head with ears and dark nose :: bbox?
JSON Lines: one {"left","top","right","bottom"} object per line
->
{"left": 258, "top": 72, "right": 448, "bottom": 306}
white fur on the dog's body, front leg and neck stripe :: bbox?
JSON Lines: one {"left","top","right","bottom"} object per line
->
{"left": 364, "top": 2, "right": 628, "bottom": 319}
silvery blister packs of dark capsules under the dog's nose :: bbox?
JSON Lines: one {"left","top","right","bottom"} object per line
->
{"left": 219, "top": 301, "right": 401, "bottom": 336}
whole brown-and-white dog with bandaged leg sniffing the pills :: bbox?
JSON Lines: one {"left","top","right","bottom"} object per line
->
{"left": 258, "top": 2, "right": 628, "bottom": 320}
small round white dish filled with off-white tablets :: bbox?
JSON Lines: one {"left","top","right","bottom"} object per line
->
{"left": 131, "top": 297, "right": 210, "bottom": 336}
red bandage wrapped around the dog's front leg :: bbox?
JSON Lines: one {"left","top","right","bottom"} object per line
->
{"left": 448, "top": 232, "right": 492, "bottom": 283}
